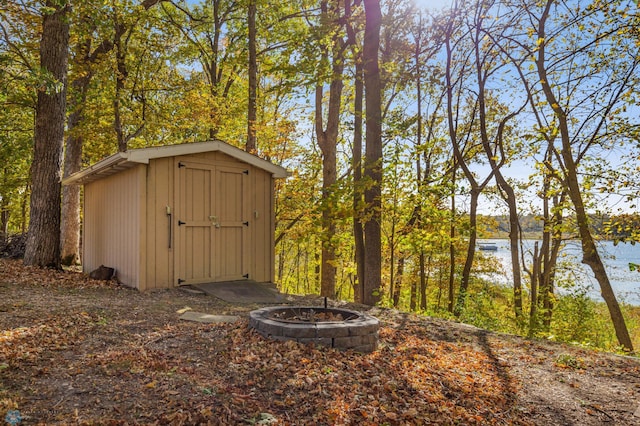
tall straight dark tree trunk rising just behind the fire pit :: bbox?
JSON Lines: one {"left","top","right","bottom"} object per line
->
{"left": 362, "top": 0, "right": 382, "bottom": 305}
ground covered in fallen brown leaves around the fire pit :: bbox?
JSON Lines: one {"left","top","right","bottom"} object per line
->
{"left": 0, "top": 259, "right": 640, "bottom": 425}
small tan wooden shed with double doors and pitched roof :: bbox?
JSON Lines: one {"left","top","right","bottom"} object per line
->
{"left": 62, "top": 141, "right": 287, "bottom": 290}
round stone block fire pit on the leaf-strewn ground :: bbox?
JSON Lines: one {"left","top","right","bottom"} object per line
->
{"left": 249, "top": 306, "right": 379, "bottom": 353}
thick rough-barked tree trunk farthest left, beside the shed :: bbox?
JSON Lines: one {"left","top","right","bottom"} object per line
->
{"left": 24, "top": 0, "right": 70, "bottom": 268}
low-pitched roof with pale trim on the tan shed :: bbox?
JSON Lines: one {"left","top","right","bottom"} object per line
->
{"left": 62, "top": 141, "right": 288, "bottom": 185}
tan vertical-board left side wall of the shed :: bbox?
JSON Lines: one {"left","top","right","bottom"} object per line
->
{"left": 83, "top": 165, "right": 146, "bottom": 287}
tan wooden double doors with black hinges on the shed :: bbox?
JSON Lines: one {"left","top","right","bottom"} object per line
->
{"left": 175, "top": 160, "right": 249, "bottom": 284}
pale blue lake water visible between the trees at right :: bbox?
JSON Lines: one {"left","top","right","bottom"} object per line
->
{"left": 478, "top": 239, "right": 640, "bottom": 306}
